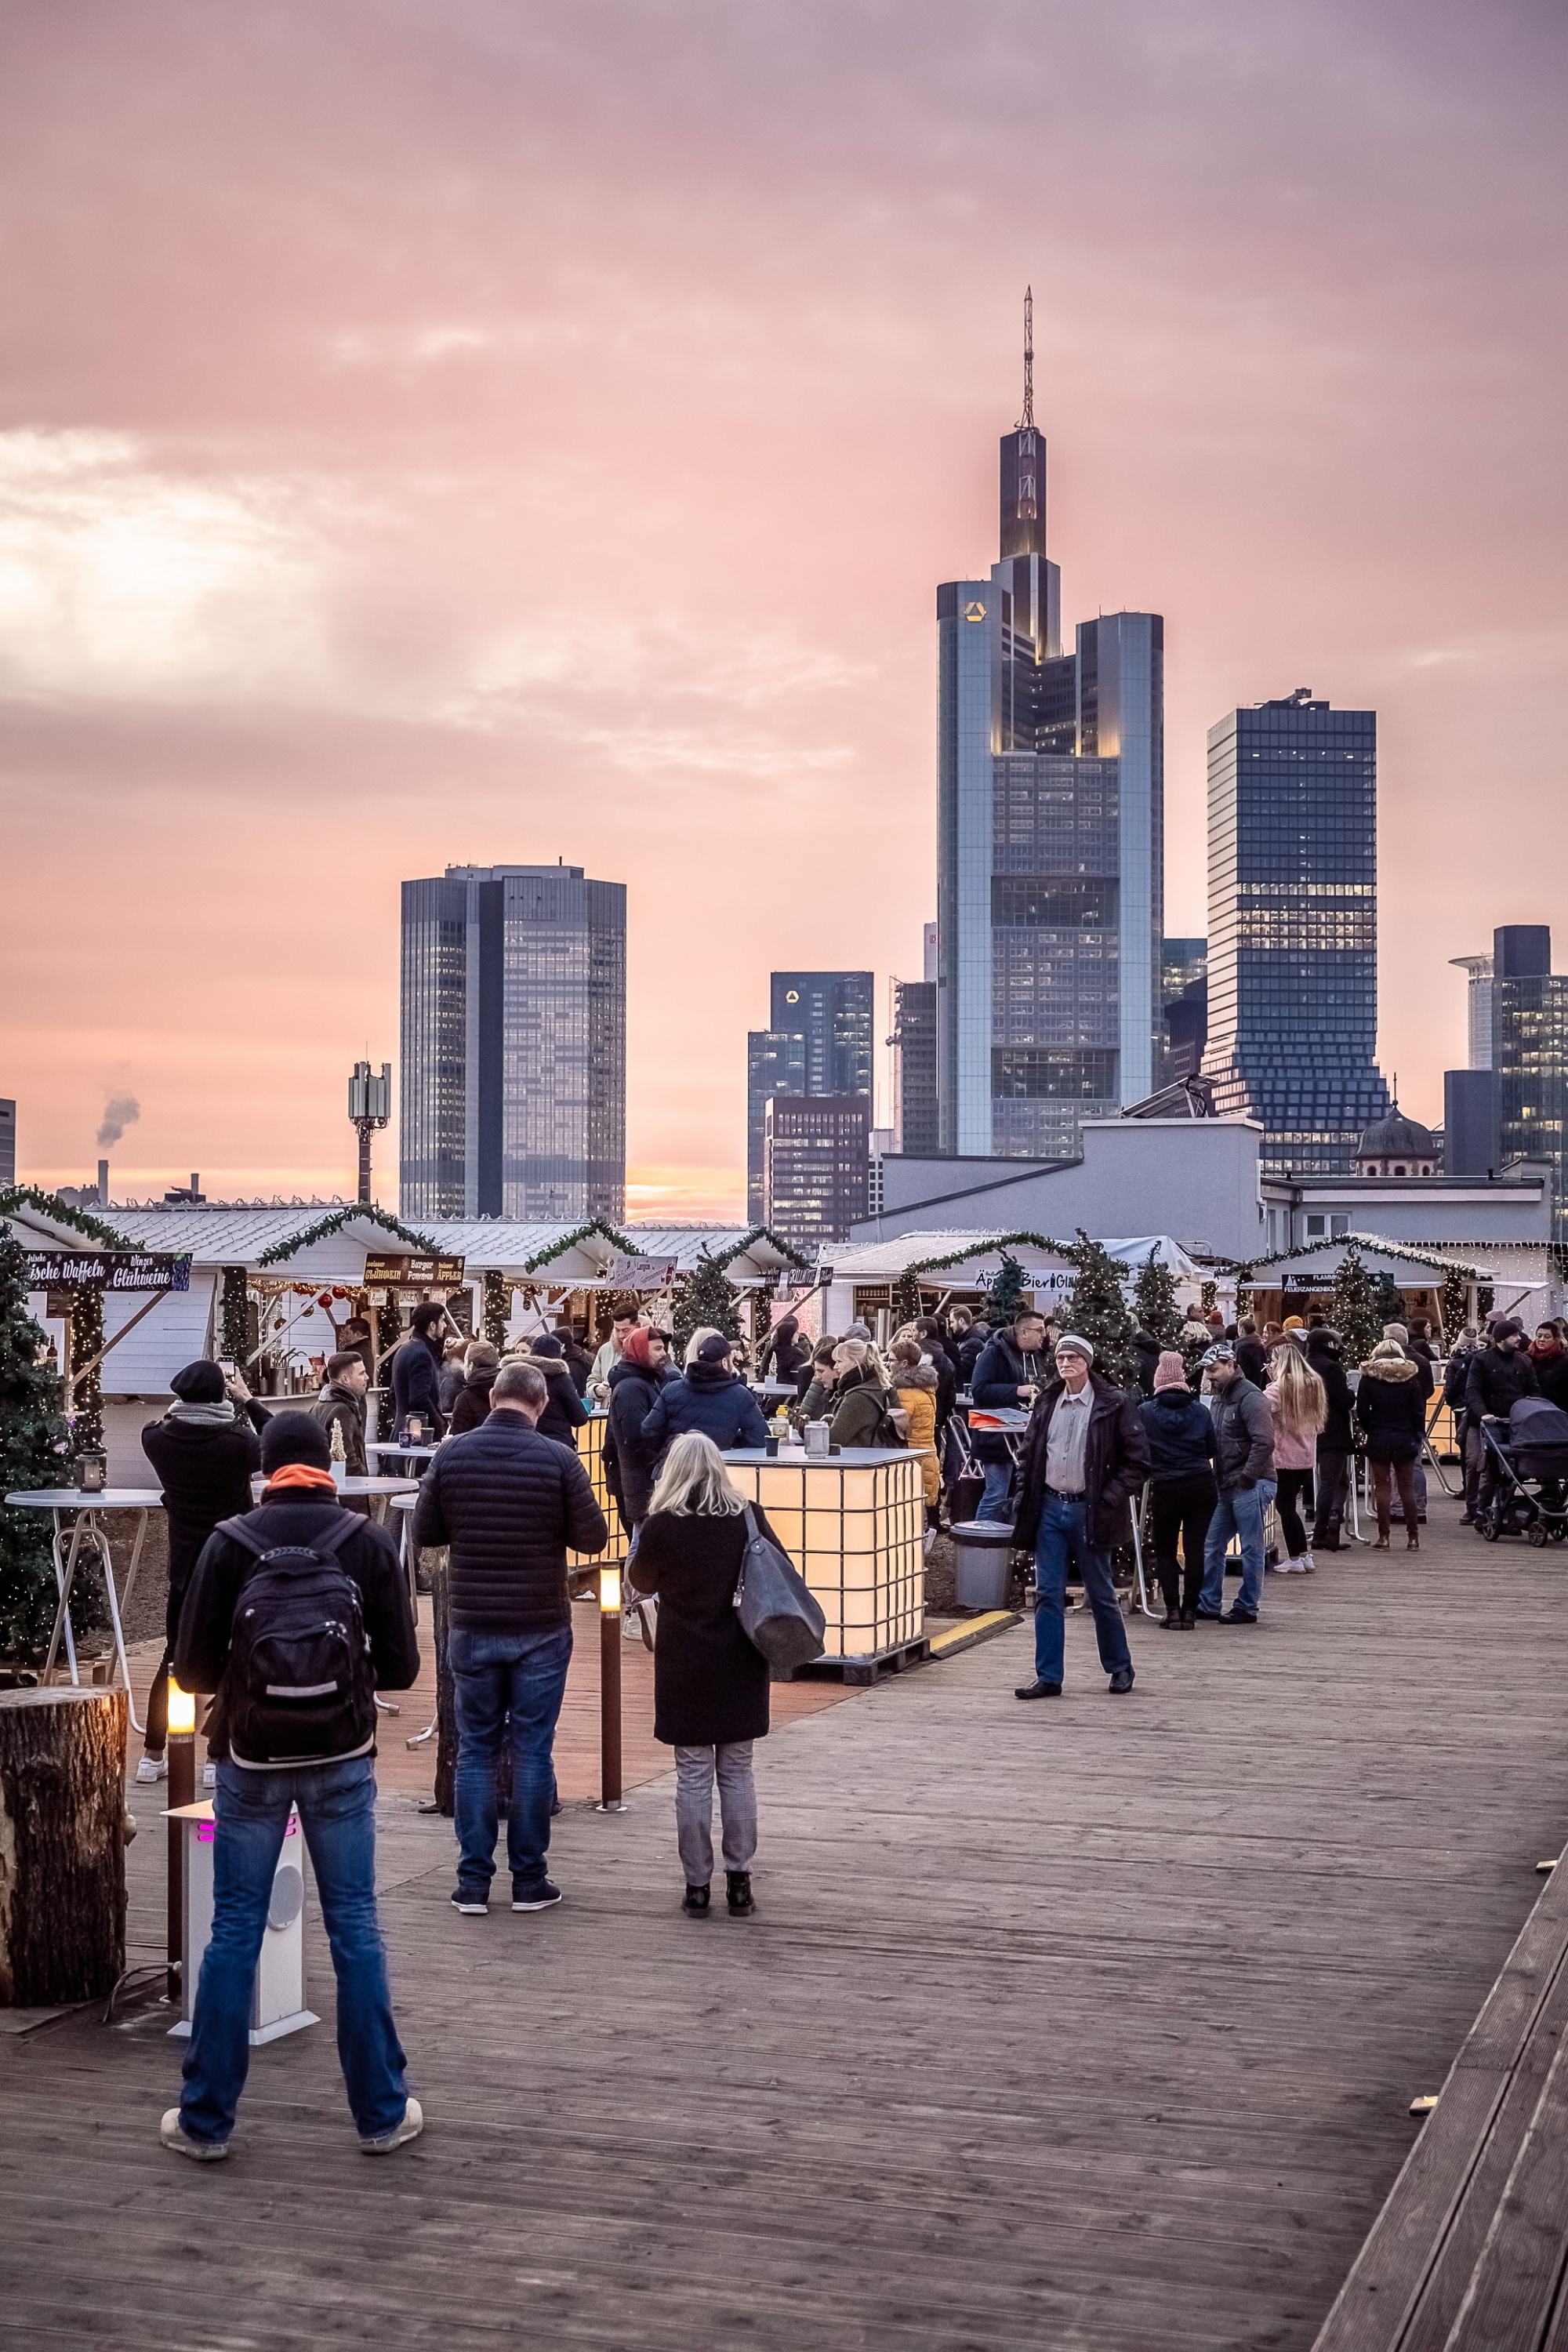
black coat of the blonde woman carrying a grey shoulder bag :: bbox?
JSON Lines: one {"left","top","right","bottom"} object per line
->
{"left": 630, "top": 1510, "right": 783, "bottom": 1748}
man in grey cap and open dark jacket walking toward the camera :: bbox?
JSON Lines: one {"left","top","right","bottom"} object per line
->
{"left": 1013, "top": 1331, "right": 1149, "bottom": 1698}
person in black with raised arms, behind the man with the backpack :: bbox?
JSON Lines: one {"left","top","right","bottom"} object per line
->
{"left": 136, "top": 1357, "right": 266, "bottom": 1780}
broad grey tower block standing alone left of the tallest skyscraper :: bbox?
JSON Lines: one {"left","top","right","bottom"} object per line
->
{"left": 400, "top": 866, "right": 626, "bottom": 1223}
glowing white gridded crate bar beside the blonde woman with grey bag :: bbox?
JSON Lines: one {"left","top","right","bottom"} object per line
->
{"left": 724, "top": 1446, "right": 926, "bottom": 1658}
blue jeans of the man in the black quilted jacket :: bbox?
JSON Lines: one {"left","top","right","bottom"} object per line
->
{"left": 447, "top": 1625, "right": 572, "bottom": 1893}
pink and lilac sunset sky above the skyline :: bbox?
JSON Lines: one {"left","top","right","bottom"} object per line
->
{"left": 0, "top": 0, "right": 1568, "bottom": 1218}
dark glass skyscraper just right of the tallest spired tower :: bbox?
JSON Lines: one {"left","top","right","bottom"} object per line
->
{"left": 1203, "top": 687, "right": 1389, "bottom": 1176}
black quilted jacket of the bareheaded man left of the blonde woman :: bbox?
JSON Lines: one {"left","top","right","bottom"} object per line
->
{"left": 414, "top": 1406, "right": 609, "bottom": 1632}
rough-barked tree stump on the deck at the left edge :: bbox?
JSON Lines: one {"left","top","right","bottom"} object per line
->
{"left": 0, "top": 1689, "right": 127, "bottom": 2009}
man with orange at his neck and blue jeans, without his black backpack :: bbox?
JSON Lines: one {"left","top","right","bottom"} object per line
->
{"left": 162, "top": 1414, "right": 423, "bottom": 2161}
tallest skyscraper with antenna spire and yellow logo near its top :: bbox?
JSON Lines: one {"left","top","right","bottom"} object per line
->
{"left": 935, "top": 308, "right": 1163, "bottom": 1157}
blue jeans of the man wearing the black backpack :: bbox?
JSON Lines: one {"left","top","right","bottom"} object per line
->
{"left": 179, "top": 1757, "right": 409, "bottom": 2140}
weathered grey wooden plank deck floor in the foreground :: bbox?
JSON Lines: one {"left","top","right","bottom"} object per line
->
{"left": 0, "top": 1498, "right": 1568, "bottom": 2352}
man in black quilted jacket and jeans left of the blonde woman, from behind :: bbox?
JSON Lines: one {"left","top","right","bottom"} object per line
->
{"left": 414, "top": 1359, "right": 609, "bottom": 1917}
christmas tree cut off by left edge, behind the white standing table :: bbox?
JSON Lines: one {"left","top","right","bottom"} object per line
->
{"left": 0, "top": 1225, "right": 64, "bottom": 1658}
